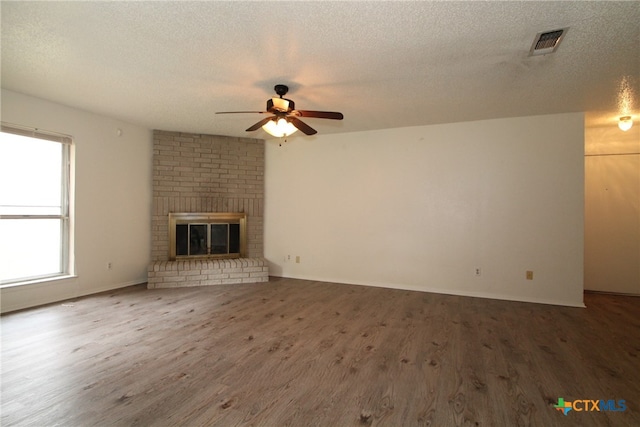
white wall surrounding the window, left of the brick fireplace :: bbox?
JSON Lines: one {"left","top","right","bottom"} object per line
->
{"left": 0, "top": 90, "right": 152, "bottom": 312}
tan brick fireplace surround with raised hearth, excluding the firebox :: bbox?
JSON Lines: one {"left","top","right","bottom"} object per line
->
{"left": 147, "top": 130, "right": 269, "bottom": 288}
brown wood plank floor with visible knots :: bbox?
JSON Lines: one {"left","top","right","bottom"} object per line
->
{"left": 1, "top": 278, "right": 640, "bottom": 427}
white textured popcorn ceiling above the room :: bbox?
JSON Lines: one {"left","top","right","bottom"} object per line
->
{"left": 0, "top": 1, "right": 640, "bottom": 138}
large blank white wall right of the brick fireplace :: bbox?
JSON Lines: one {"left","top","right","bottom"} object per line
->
{"left": 265, "top": 113, "right": 584, "bottom": 306}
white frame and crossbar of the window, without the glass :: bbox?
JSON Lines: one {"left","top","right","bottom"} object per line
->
{"left": 0, "top": 122, "right": 75, "bottom": 288}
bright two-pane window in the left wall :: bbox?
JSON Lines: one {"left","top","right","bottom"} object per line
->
{"left": 0, "top": 123, "right": 72, "bottom": 285}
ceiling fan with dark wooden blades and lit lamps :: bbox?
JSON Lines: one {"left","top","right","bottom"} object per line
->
{"left": 216, "top": 85, "right": 344, "bottom": 137}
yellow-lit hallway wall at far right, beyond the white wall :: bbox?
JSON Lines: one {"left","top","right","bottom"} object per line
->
{"left": 584, "top": 123, "right": 640, "bottom": 295}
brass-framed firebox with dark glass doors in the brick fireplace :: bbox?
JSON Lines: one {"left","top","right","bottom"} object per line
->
{"left": 169, "top": 212, "right": 247, "bottom": 261}
